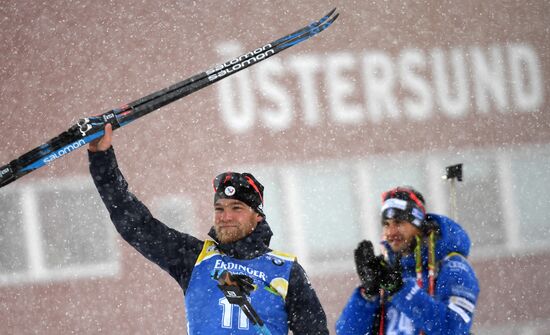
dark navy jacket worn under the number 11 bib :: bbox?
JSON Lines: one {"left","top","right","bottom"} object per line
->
{"left": 89, "top": 148, "right": 328, "bottom": 335}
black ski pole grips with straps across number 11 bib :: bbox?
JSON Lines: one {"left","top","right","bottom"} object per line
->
{"left": 212, "top": 270, "right": 271, "bottom": 335}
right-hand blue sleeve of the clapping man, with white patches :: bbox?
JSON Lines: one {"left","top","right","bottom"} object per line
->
{"left": 391, "top": 256, "right": 479, "bottom": 335}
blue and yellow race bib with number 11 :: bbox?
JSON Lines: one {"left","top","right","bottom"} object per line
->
{"left": 185, "top": 241, "right": 295, "bottom": 335}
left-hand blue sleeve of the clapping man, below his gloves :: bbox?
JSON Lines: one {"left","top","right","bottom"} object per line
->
{"left": 336, "top": 287, "right": 380, "bottom": 335}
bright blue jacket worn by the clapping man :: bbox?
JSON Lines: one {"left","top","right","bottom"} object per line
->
{"left": 336, "top": 214, "right": 479, "bottom": 335}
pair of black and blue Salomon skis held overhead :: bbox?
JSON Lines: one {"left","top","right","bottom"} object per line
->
{"left": 0, "top": 8, "right": 339, "bottom": 187}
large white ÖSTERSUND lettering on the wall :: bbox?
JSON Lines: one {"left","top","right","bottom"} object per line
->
{"left": 210, "top": 43, "right": 545, "bottom": 134}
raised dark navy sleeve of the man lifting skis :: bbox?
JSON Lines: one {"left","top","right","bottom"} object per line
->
{"left": 88, "top": 147, "right": 204, "bottom": 291}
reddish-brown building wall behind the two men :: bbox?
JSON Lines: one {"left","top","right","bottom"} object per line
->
{"left": 0, "top": 0, "right": 550, "bottom": 334}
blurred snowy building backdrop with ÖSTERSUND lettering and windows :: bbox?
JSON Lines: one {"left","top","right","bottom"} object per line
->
{"left": 0, "top": 0, "right": 550, "bottom": 335}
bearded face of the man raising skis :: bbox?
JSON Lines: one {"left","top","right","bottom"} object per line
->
{"left": 214, "top": 199, "right": 263, "bottom": 243}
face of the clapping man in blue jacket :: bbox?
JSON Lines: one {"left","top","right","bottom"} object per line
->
{"left": 382, "top": 219, "right": 420, "bottom": 253}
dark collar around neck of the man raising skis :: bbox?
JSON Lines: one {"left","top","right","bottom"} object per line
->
{"left": 208, "top": 219, "right": 273, "bottom": 259}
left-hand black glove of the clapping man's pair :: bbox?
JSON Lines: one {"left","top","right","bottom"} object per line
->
{"left": 355, "top": 241, "right": 384, "bottom": 297}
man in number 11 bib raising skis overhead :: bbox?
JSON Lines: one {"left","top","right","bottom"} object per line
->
{"left": 89, "top": 125, "right": 328, "bottom": 335}
